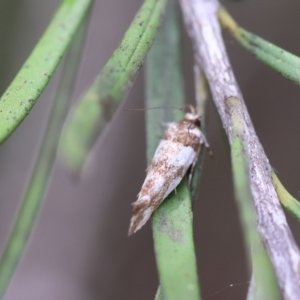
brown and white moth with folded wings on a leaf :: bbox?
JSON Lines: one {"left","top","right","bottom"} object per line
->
{"left": 128, "top": 106, "right": 211, "bottom": 235}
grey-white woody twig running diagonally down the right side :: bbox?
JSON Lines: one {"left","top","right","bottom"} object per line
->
{"left": 181, "top": 0, "right": 300, "bottom": 299}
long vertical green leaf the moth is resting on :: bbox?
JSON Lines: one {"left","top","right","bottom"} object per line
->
{"left": 146, "top": 0, "right": 200, "bottom": 300}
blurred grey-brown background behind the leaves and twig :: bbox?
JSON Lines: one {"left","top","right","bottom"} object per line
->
{"left": 0, "top": 0, "right": 300, "bottom": 300}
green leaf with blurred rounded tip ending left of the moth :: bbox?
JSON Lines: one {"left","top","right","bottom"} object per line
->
{"left": 60, "top": 0, "right": 167, "bottom": 172}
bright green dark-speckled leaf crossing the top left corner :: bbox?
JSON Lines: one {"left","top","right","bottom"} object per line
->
{"left": 0, "top": 0, "right": 92, "bottom": 143}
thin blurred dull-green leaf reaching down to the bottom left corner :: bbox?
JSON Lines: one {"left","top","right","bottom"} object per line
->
{"left": 0, "top": 10, "right": 87, "bottom": 299}
